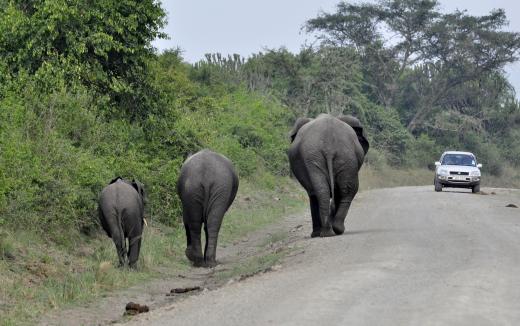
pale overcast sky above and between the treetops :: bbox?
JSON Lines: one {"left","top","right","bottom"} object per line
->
{"left": 154, "top": 0, "right": 520, "bottom": 97}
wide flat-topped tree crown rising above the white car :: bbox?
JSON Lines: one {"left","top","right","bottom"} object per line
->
{"left": 306, "top": 0, "right": 520, "bottom": 132}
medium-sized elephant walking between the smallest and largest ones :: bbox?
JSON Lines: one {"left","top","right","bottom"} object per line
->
{"left": 177, "top": 149, "right": 238, "bottom": 267}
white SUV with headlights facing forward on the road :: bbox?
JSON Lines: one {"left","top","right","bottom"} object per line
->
{"left": 433, "top": 151, "right": 482, "bottom": 193}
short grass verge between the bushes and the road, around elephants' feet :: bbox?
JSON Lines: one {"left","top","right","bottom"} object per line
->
{"left": 0, "top": 177, "right": 306, "bottom": 325}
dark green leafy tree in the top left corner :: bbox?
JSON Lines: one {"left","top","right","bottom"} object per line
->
{"left": 0, "top": 0, "right": 166, "bottom": 115}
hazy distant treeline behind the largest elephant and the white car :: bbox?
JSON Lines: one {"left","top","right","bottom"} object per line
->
{"left": 194, "top": 0, "right": 520, "bottom": 175}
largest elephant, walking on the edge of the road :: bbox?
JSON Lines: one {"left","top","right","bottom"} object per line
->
{"left": 288, "top": 114, "right": 369, "bottom": 237}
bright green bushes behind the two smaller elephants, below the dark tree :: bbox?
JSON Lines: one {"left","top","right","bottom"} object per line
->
{"left": 0, "top": 43, "right": 290, "bottom": 236}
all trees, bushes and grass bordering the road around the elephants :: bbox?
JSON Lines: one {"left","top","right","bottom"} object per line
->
{"left": 0, "top": 0, "right": 520, "bottom": 325}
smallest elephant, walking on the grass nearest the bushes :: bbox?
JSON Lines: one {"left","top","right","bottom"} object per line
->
{"left": 99, "top": 177, "right": 146, "bottom": 268}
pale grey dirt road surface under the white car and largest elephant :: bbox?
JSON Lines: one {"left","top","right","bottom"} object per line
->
{"left": 119, "top": 186, "right": 520, "bottom": 326}
